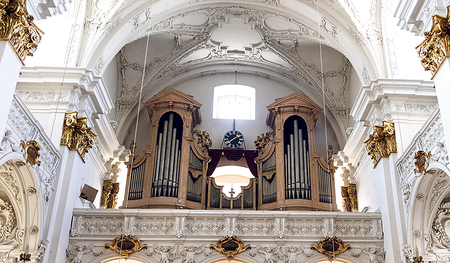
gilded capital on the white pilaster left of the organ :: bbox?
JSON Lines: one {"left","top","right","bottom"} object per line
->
{"left": 61, "top": 111, "right": 97, "bottom": 162}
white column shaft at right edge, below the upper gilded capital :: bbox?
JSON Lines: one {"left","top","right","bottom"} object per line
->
{"left": 434, "top": 58, "right": 450, "bottom": 153}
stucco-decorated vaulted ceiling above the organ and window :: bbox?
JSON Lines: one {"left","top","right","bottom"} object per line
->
{"left": 110, "top": 5, "right": 360, "bottom": 146}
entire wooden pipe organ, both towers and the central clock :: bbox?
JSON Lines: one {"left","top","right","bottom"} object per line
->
{"left": 123, "top": 89, "right": 337, "bottom": 211}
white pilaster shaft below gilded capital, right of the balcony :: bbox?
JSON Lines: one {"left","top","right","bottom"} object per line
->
{"left": 372, "top": 153, "right": 406, "bottom": 262}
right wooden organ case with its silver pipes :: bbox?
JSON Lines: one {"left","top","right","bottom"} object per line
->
{"left": 255, "top": 94, "right": 337, "bottom": 211}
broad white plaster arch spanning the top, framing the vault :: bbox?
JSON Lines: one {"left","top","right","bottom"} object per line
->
{"left": 79, "top": 0, "right": 384, "bottom": 82}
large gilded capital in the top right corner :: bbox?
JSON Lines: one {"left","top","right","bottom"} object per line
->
{"left": 416, "top": 6, "right": 450, "bottom": 78}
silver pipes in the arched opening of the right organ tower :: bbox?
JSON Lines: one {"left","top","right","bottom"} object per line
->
{"left": 284, "top": 119, "right": 311, "bottom": 199}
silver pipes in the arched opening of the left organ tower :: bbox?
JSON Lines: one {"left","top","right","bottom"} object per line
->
{"left": 152, "top": 113, "right": 180, "bottom": 197}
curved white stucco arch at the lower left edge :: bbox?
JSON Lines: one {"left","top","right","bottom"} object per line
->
{"left": 0, "top": 155, "right": 44, "bottom": 258}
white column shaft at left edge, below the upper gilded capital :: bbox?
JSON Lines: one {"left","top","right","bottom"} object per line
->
{"left": 0, "top": 41, "right": 22, "bottom": 137}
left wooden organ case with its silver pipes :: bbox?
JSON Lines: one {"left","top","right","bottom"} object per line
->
{"left": 123, "top": 89, "right": 210, "bottom": 209}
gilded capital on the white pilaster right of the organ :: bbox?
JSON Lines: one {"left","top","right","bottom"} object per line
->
{"left": 364, "top": 121, "right": 397, "bottom": 168}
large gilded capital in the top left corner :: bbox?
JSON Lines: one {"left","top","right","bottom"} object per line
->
{"left": 0, "top": 0, "right": 43, "bottom": 64}
